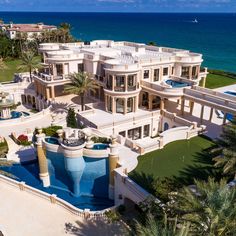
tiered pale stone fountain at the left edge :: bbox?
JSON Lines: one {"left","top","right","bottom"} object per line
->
{"left": 0, "top": 92, "right": 14, "bottom": 120}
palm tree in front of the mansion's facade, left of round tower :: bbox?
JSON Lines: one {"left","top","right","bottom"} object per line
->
{"left": 64, "top": 72, "right": 99, "bottom": 111}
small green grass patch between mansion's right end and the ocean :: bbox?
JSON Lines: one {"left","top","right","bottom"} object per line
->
{"left": 206, "top": 70, "right": 236, "bottom": 89}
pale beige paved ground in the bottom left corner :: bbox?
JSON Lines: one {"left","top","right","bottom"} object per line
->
{"left": 0, "top": 183, "right": 127, "bottom": 236}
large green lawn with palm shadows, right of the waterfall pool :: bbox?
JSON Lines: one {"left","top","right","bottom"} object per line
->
{"left": 129, "top": 136, "right": 216, "bottom": 187}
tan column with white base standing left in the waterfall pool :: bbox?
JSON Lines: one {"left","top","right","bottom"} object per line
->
{"left": 36, "top": 129, "right": 50, "bottom": 187}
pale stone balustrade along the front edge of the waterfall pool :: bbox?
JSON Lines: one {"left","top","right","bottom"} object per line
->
{"left": 0, "top": 175, "right": 115, "bottom": 219}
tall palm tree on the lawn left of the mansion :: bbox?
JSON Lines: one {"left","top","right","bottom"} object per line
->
{"left": 18, "top": 51, "right": 41, "bottom": 82}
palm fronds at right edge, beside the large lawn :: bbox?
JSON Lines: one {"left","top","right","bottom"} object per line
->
{"left": 213, "top": 119, "right": 236, "bottom": 179}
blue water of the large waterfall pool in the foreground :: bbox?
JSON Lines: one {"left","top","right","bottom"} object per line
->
{"left": 0, "top": 151, "right": 114, "bottom": 211}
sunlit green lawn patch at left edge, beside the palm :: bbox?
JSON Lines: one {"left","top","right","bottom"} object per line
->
{"left": 0, "top": 59, "right": 21, "bottom": 82}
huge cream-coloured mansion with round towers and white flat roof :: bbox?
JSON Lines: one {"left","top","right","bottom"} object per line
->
{"left": 30, "top": 40, "right": 207, "bottom": 139}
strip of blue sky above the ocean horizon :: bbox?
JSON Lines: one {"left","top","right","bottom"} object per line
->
{"left": 0, "top": 0, "right": 236, "bottom": 12}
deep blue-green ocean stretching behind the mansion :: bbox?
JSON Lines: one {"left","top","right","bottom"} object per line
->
{"left": 0, "top": 12, "right": 236, "bottom": 72}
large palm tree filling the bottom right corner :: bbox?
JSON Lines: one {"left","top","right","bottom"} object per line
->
{"left": 169, "top": 178, "right": 236, "bottom": 236}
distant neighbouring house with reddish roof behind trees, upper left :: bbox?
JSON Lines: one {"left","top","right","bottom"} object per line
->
{"left": 0, "top": 23, "right": 57, "bottom": 40}
